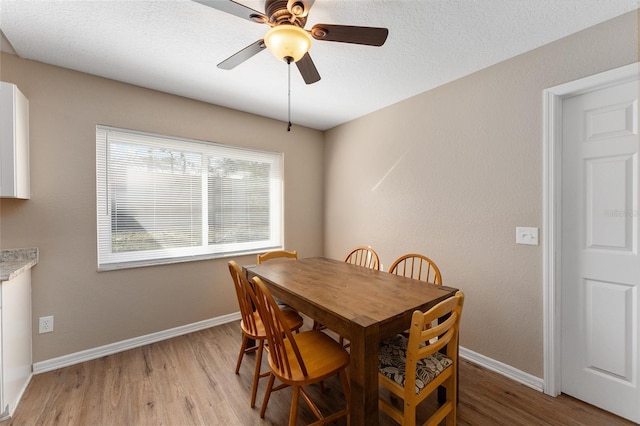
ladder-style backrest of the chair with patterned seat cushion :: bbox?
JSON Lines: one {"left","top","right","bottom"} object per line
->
{"left": 404, "top": 291, "right": 464, "bottom": 390}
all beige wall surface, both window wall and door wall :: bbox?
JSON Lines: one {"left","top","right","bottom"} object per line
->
{"left": 0, "top": 13, "right": 639, "bottom": 377}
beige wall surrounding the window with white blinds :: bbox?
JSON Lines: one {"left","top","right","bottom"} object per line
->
{"left": 0, "top": 53, "right": 323, "bottom": 362}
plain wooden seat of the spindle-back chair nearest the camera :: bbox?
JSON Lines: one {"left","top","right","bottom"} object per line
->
{"left": 269, "top": 330, "right": 349, "bottom": 384}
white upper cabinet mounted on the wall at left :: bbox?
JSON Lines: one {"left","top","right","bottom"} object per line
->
{"left": 0, "top": 82, "right": 31, "bottom": 199}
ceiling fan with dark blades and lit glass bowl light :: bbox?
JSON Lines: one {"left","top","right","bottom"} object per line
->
{"left": 194, "top": 0, "right": 389, "bottom": 84}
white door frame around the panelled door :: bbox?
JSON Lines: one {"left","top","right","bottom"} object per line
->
{"left": 542, "top": 62, "right": 640, "bottom": 396}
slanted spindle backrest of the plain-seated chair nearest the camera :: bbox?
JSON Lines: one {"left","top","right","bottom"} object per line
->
{"left": 252, "top": 277, "right": 307, "bottom": 377}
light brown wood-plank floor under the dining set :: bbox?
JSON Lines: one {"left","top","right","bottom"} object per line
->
{"left": 0, "top": 322, "right": 634, "bottom": 426}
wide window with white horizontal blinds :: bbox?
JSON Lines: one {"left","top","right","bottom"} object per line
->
{"left": 96, "top": 126, "right": 283, "bottom": 269}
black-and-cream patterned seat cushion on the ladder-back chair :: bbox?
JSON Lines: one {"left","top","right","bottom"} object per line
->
{"left": 378, "top": 334, "right": 453, "bottom": 394}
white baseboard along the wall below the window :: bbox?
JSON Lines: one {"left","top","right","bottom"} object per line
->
{"left": 33, "top": 312, "right": 240, "bottom": 374}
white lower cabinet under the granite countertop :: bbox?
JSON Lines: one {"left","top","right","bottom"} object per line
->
{"left": 0, "top": 269, "right": 32, "bottom": 421}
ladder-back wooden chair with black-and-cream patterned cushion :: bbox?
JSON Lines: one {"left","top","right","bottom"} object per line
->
{"left": 378, "top": 291, "right": 464, "bottom": 426}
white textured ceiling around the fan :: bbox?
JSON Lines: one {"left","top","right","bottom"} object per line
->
{"left": 0, "top": 0, "right": 639, "bottom": 130}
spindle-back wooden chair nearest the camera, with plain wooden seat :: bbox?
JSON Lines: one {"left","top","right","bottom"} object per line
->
{"left": 253, "top": 277, "right": 350, "bottom": 426}
